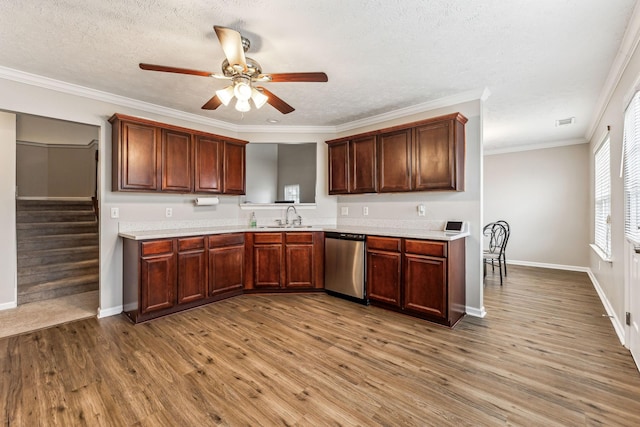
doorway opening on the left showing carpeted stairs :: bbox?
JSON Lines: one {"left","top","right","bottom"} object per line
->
{"left": 16, "top": 114, "right": 100, "bottom": 328}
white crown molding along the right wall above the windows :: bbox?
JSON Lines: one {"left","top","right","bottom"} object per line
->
{"left": 585, "top": 3, "right": 640, "bottom": 141}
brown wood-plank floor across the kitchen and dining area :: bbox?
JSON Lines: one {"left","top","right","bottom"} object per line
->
{"left": 0, "top": 267, "right": 640, "bottom": 426}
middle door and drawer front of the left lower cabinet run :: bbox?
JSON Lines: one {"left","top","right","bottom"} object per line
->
{"left": 178, "top": 236, "right": 207, "bottom": 304}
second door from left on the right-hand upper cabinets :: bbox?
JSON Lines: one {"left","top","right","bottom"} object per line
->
{"left": 349, "top": 135, "right": 378, "bottom": 193}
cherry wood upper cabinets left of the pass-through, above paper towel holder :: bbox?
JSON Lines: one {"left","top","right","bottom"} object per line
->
{"left": 109, "top": 114, "right": 247, "bottom": 194}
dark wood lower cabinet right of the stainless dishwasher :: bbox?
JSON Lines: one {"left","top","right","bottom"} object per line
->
{"left": 367, "top": 236, "right": 465, "bottom": 326}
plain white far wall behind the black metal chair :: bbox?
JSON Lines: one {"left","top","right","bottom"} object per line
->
{"left": 484, "top": 144, "right": 590, "bottom": 268}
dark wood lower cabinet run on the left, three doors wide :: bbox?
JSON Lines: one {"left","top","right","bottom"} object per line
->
{"left": 123, "top": 233, "right": 245, "bottom": 323}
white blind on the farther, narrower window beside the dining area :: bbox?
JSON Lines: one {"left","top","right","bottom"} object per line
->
{"left": 595, "top": 136, "right": 611, "bottom": 258}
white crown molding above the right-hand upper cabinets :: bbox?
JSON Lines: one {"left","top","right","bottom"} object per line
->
{"left": 335, "top": 87, "right": 491, "bottom": 133}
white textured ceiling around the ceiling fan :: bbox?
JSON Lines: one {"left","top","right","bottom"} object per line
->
{"left": 0, "top": 0, "right": 636, "bottom": 150}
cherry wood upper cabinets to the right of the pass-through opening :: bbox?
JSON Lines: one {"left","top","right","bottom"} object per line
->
{"left": 327, "top": 113, "right": 467, "bottom": 194}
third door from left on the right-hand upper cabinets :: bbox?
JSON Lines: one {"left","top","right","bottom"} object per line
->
{"left": 378, "top": 129, "right": 412, "bottom": 193}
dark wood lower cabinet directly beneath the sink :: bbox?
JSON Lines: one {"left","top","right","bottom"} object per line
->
{"left": 245, "top": 231, "right": 324, "bottom": 291}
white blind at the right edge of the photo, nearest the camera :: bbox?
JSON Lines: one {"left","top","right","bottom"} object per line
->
{"left": 623, "top": 92, "right": 640, "bottom": 242}
